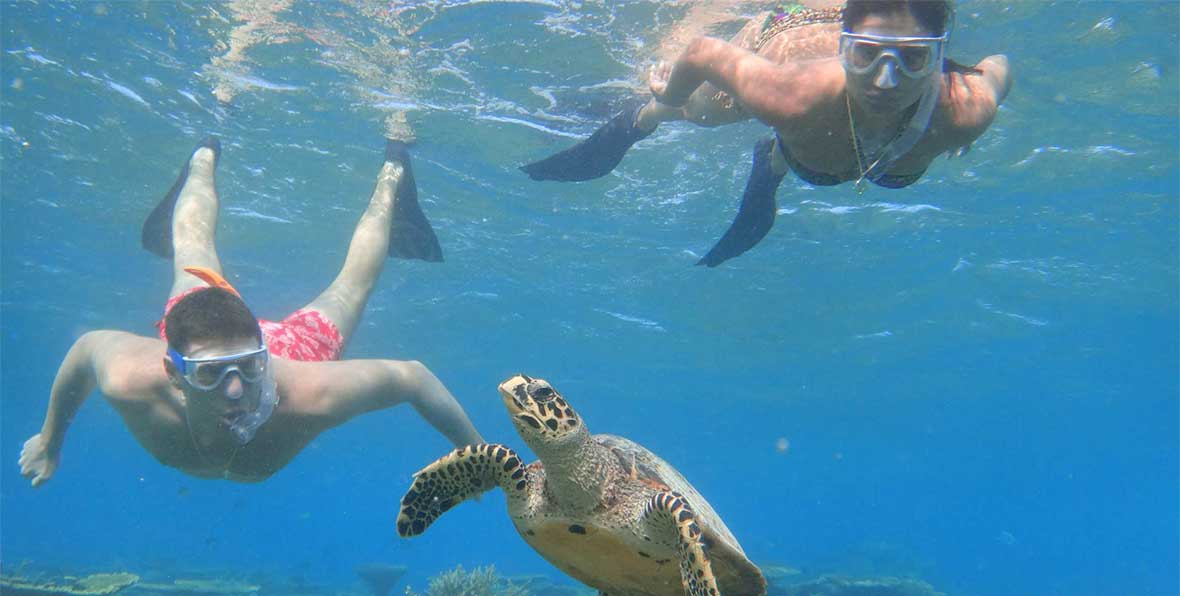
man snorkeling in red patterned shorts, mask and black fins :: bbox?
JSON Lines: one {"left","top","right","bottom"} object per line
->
{"left": 20, "top": 138, "right": 483, "bottom": 486}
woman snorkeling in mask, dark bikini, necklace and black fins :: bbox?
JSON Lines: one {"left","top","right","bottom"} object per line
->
{"left": 522, "top": 0, "right": 1011, "bottom": 267}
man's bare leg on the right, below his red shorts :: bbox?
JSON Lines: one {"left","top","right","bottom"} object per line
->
{"left": 303, "top": 142, "right": 415, "bottom": 343}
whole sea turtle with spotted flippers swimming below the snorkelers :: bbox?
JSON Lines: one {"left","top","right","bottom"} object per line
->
{"left": 398, "top": 375, "right": 766, "bottom": 596}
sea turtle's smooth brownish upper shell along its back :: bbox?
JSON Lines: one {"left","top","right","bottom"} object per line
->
{"left": 594, "top": 434, "right": 766, "bottom": 596}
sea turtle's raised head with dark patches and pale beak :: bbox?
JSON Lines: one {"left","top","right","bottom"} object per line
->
{"left": 500, "top": 374, "right": 585, "bottom": 443}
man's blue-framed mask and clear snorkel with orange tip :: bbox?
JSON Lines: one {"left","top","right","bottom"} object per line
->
{"left": 168, "top": 267, "right": 278, "bottom": 445}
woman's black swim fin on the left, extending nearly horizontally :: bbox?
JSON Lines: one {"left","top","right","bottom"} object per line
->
{"left": 520, "top": 99, "right": 654, "bottom": 182}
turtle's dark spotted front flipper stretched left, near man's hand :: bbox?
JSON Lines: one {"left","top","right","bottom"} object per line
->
{"left": 398, "top": 444, "right": 527, "bottom": 538}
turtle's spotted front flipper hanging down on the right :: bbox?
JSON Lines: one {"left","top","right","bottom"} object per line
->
{"left": 643, "top": 492, "right": 719, "bottom": 596}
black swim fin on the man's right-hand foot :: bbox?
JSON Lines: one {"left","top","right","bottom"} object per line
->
{"left": 385, "top": 140, "right": 443, "bottom": 263}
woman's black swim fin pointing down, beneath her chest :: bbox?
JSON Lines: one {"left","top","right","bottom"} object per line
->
{"left": 696, "top": 137, "right": 786, "bottom": 267}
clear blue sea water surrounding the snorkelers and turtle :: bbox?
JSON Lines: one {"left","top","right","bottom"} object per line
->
{"left": 0, "top": 0, "right": 1180, "bottom": 596}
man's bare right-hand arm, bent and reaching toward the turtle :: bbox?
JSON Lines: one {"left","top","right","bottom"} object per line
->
{"left": 317, "top": 360, "right": 484, "bottom": 447}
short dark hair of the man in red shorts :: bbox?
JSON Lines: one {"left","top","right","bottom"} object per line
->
{"left": 164, "top": 288, "right": 262, "bottom": 354}
